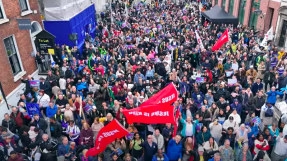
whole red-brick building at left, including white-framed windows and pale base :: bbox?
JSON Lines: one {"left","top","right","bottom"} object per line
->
{"left": 0, "top": 0, "right": 42, "bottom": 118}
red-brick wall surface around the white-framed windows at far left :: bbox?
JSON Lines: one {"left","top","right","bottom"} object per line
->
{"left": 0, "top": 0, "right": 41, "bottom": 98}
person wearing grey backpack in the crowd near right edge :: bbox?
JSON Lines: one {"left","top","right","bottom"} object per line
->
{"left": 260, "top": 102, "right": 274, "bottom": 127}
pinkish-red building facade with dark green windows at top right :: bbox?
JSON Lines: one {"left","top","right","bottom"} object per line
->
{"left": 212, "top": 0, "right": 280, "bottom": 33}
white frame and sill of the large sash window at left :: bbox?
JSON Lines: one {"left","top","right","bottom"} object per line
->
{"left": 2, "top": 34, "right": 26, "bottom": 82}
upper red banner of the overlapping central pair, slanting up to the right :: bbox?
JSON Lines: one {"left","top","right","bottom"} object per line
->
{"left": 140, "top": 83, "right": 178, "bottom": 107}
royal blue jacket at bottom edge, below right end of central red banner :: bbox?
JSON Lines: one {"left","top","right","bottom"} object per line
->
{"left": 167, "top": 139, "right": 182, "bottom": 160}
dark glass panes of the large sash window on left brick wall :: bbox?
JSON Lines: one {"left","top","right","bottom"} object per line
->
{"left": 4, "top": 36, "right": 22, "bottom": 76}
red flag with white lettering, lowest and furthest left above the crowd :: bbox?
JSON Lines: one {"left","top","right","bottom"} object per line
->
{"left": 86, "top": 119, "right": 129, "bottom": 156}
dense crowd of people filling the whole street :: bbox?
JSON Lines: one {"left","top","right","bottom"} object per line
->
{"left": 0, "top": 0, "right": 287, "bottom": 161}
